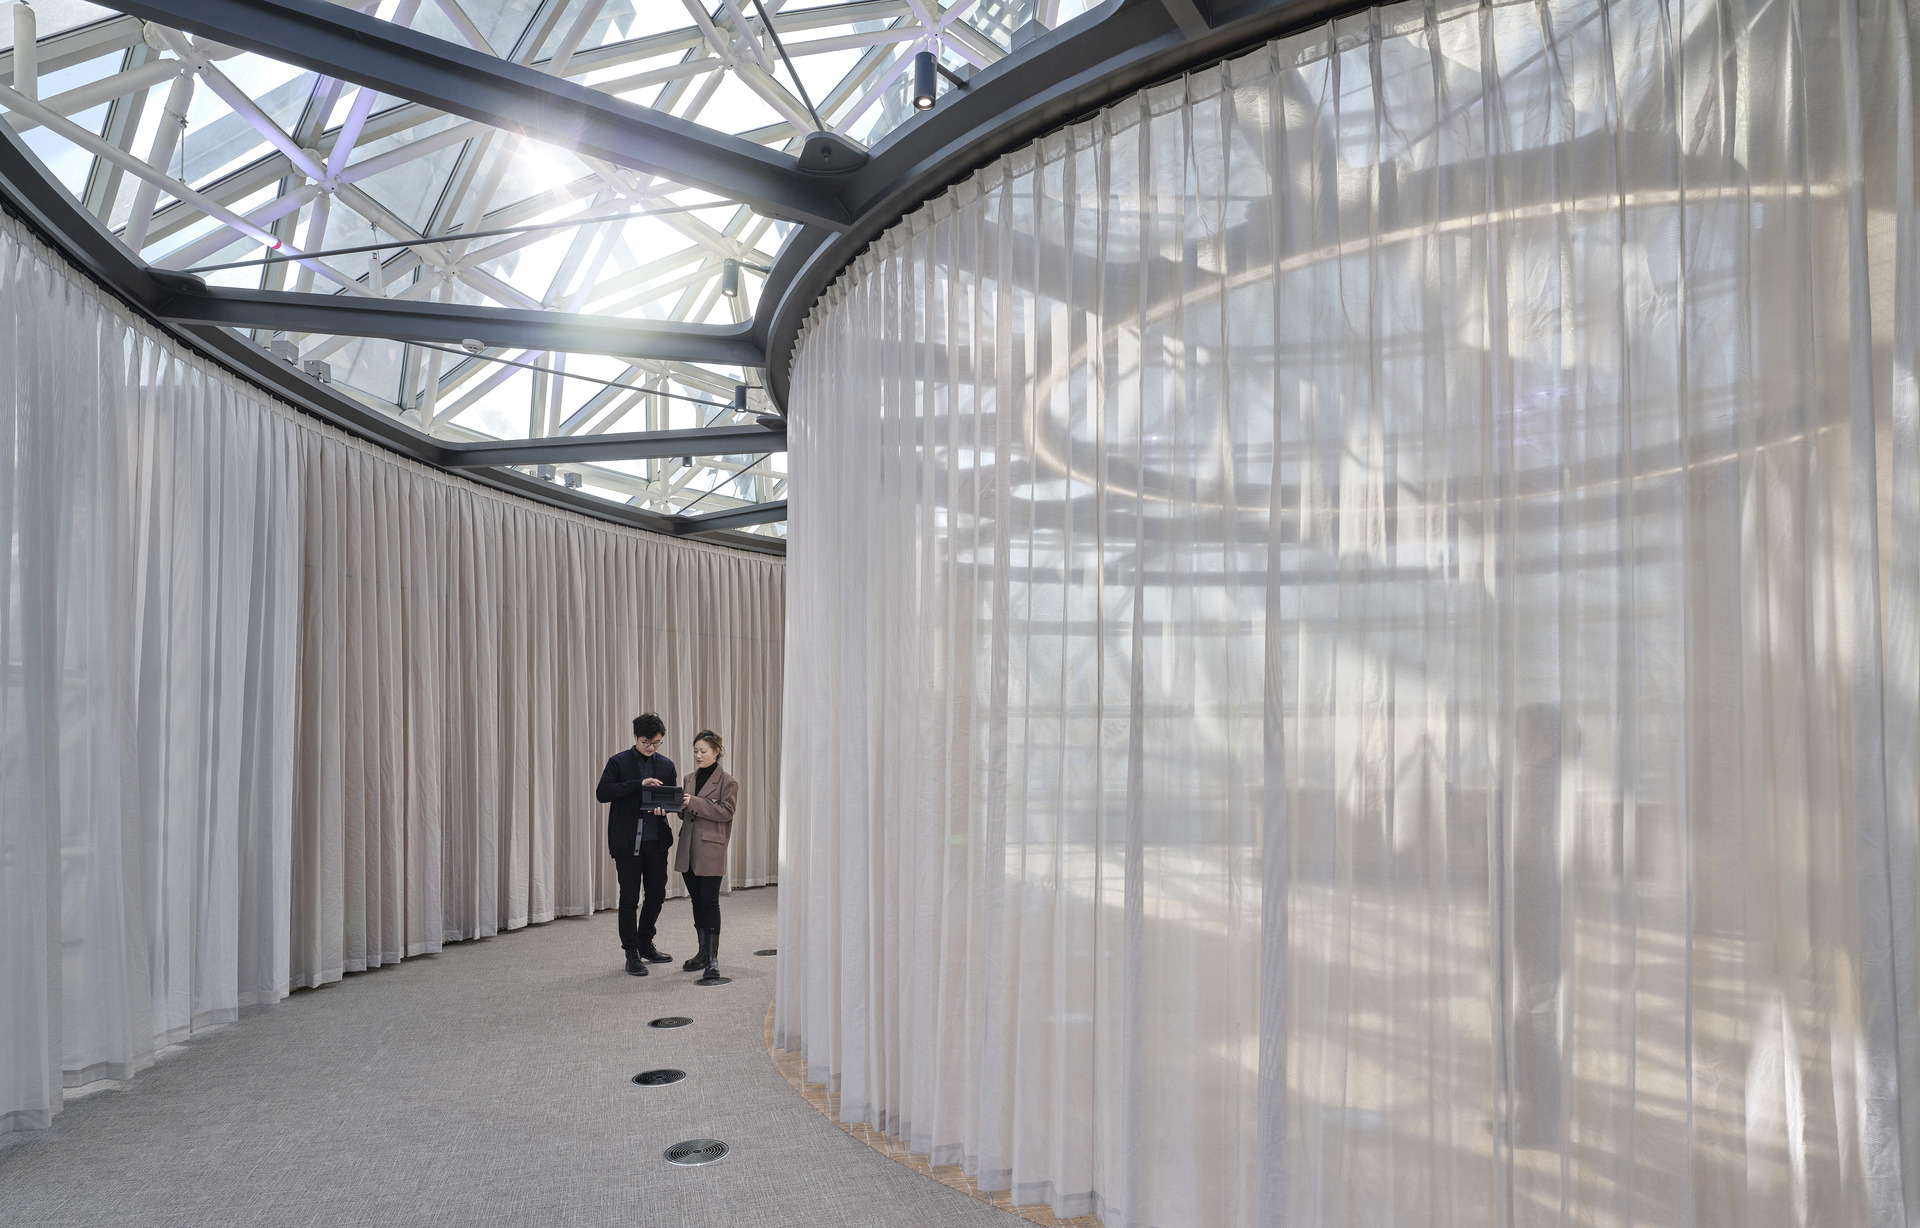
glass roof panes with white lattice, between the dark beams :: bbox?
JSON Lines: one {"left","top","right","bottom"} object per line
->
{"left": 0, "top": 0, "right": 1113, "bottom": 535}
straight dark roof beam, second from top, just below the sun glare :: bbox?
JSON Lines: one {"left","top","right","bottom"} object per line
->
{"left": 154, "top": 278, "right": 766, "bottom": 366}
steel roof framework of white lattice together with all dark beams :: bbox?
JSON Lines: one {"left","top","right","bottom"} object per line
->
{"left": 0, "top": 0, "right": 1361, "bottom": 549}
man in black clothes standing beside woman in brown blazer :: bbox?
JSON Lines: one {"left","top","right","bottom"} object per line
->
{"left": 593, "top": 712, "right": 680, "bottom": 977}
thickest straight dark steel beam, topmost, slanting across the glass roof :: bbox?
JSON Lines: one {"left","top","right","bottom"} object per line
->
{"left": 117, "top": 0, "right": 849, "bottom": 226}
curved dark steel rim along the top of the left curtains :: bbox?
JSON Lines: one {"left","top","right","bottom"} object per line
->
{"left": 0, "top": 123, "right": 787, "bottom": 555}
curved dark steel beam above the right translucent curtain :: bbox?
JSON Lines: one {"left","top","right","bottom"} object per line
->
{"left": 755, "top": 0, "right": 1369, "bottom": 405}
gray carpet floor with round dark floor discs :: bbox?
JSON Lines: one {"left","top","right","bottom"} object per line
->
{"left": 0, "top": 886, "right": 1020, "bottom": 1228}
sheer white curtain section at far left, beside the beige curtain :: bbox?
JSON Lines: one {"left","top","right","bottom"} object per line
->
{"left": 0, "top": 219, "right": 300, "bottom": 1128}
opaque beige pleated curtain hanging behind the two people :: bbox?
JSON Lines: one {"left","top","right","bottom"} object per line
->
{"left": 292, "top": 437, "right": 783, "bottom": 986}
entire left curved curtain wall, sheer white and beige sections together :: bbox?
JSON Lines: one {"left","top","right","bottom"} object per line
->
{"left": 0, "top": 209, "right": 785, "bottom": 1128}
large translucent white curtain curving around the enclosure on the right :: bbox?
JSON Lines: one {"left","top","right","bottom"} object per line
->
{"left": 778, "top": 0, "right": 1920, "bottom": 1228}
